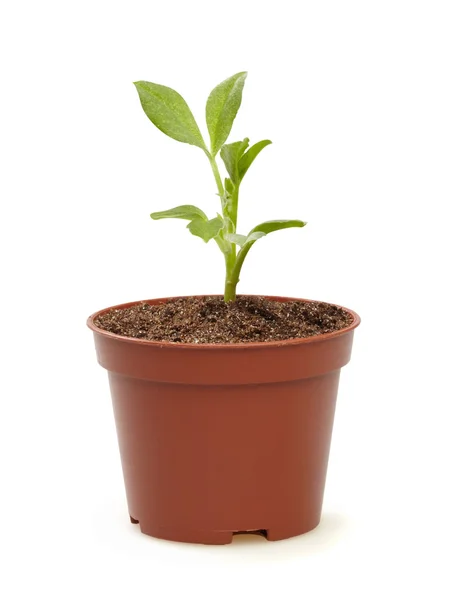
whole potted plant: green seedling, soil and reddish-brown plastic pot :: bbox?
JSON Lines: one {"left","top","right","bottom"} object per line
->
{"left": 88, "top": 73, "right": 360, "bottom": 544}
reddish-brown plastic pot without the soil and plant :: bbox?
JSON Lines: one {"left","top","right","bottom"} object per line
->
{"left": 88, "top": 297, "right": 360, "bottom": 544}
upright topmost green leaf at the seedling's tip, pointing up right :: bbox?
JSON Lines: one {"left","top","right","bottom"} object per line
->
{"left": 206, "top": 71, "right": 247, "bottom": 156}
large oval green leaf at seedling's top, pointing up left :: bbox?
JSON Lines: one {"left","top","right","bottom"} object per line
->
{"left": 134, "top": 81, "right": 207, "bottom": 151}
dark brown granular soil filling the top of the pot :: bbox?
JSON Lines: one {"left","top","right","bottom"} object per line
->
{"left": 95, "top": 296, "right": 353, "bottom": 344}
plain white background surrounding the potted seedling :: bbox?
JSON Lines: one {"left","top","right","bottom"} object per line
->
{"left": 0, "top": 0, "right": 450, "bottom": 600}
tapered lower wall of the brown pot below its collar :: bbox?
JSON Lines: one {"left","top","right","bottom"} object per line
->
{"left": 110, "top": 371, "right": 339, "bottom": 542}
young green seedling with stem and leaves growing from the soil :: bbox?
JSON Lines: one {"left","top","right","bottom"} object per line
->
{"left": 134, "top": 72, "right": 306, "bottom": 302}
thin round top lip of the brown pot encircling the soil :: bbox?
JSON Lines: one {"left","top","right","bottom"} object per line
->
{"left": 86, "top": 294, "right": 361, "bottom": 350}
